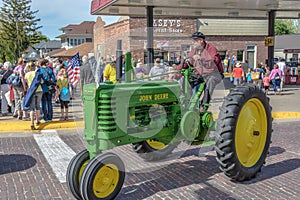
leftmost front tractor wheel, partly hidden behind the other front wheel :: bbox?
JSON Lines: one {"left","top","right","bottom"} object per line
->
{"left": 66, "top": 149, "right": 90, "bottom": 200}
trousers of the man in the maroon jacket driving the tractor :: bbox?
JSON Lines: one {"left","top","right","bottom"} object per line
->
{"left": 193, "top": 72, "right": 222, "bottom": 107}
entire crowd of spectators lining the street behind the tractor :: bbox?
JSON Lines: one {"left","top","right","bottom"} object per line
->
{"left": 0, "top": 55, "right": 285, "bottom": 129}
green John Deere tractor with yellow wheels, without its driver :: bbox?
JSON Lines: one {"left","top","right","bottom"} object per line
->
{"left": 67, "top": 54, "right": 272, "bottom": 200}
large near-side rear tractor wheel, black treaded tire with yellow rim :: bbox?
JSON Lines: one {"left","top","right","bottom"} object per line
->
{"left": 216, "top": 85, "right": 272, "bottom": 181}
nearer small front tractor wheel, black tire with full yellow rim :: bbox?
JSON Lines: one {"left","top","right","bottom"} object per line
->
{"left": 80, "top": 153, "right": 125, "bottom": 200}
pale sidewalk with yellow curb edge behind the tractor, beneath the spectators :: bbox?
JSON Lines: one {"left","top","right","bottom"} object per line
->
{"left": 0, "top": 85, "right": 300, "bottom": 133}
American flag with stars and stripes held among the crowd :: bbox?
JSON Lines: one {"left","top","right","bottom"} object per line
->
{"left": 67, "top": 53, "right": 80, "bottom": 88}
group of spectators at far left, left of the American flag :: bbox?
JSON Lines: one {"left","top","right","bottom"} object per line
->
{"left": 0, "top": 55, "right": 72, "bottom": 130}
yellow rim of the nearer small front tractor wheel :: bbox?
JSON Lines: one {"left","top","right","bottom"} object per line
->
{"left": 93, "top": 164, "right": 120, "bottom": 198}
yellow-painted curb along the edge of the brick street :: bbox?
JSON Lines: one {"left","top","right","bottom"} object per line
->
{"left": 0, "top": 112, "right": 300, "bottom": 133}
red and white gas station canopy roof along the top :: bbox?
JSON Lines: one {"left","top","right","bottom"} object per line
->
{"left": 91, "top": 0, "right": 300, "bottom": 19}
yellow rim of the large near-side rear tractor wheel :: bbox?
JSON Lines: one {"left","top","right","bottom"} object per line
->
{"left": 235, "top": 98, "right": 268, "bottom": 167}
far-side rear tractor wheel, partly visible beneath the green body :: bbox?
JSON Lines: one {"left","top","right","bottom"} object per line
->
{"left": 132, "top": 140, "right": 177, "bottom": 161}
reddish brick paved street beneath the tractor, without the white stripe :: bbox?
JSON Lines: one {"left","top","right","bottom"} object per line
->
{"left": 0, "top": 118, "right": 300, "bottom": 200}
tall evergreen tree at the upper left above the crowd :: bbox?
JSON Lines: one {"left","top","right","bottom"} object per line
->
{"left": 0, "top": 0, "right": 46, "bottom": 61}
